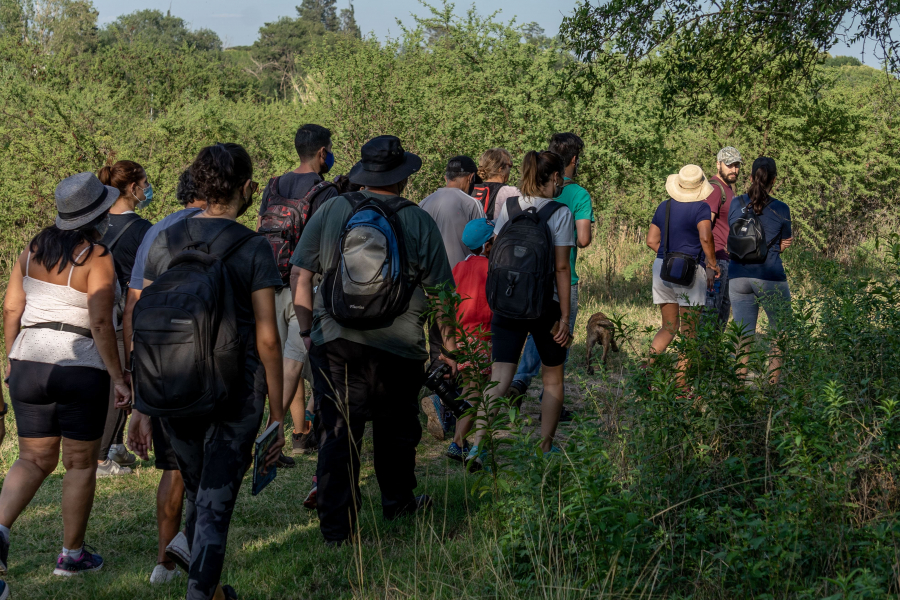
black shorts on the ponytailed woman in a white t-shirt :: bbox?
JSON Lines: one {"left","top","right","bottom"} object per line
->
{"left": 491, "top": 300, "right": 566, "bottom": 367}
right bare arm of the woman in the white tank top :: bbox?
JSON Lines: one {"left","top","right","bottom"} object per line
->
{"left": 87, "top": 248, "right": 131, "bottom": 408}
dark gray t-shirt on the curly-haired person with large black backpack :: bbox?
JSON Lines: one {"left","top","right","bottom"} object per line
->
{"left": 144, "top": 217, "right": 282, "bottom": 385}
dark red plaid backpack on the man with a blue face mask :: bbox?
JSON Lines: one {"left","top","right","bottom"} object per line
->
{"left": 257, "top": 177, "right": 338, "bottom": 284}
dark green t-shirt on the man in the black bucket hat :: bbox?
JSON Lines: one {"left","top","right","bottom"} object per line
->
{"left": 291, "top": 192, "right": 454, "bottom": 360}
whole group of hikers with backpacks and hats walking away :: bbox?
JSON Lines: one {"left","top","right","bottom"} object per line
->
{"left": 0, "top": 118, "right": 791, "bottom": 600}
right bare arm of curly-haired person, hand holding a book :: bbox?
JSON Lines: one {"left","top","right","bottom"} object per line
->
{"left": 251, "top": 287, "right": 284, "bottom": 470}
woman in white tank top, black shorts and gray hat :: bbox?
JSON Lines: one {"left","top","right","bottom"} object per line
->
{"left": 0, "top": 173, "right": 131, "bottom": 576}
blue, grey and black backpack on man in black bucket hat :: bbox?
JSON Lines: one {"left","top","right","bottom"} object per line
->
{"left": 321, "top": 192, "right": 419, "bottom": 331}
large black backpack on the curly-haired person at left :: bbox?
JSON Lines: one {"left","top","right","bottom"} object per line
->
{"left": 131, "top": 219, "right": 257, "bottom": 417}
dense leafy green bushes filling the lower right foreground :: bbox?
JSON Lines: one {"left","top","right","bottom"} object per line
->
{"left": 487, "top": 237, "right": 900, "bottom": 598}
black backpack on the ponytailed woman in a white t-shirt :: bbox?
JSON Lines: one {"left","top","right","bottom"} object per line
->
{"left": 485, "top": 197, "right": 565, "bottom": 319}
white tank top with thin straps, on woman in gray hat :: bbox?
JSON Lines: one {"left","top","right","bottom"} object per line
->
{"left": 9, "top": 246, "right": 106, "bottom": 370}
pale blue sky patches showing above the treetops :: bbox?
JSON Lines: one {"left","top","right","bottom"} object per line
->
{"left": 94, "top": 0, "right": 878, "bottom": 67}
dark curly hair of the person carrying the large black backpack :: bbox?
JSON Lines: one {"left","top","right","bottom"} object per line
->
{"left": 190, "top": 144, "right": 253, "bottom": 204}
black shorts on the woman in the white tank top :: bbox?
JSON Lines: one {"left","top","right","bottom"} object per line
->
{"left": 9, "top": 360, "right": 109, "bottom": 442}
